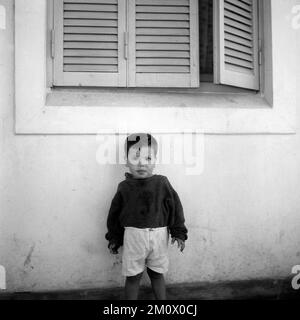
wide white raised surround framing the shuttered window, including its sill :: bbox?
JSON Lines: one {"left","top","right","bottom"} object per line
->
{"left": 15, "top": 0, "right": 297, "bottom": 134}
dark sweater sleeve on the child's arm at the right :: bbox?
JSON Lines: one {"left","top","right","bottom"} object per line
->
{"left": 166, "top": 179, "right": 188, "bottom": 241}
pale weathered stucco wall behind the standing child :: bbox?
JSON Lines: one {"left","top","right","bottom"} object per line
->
{"left": 0, "top": 0, "right": 300, "bottom": 291}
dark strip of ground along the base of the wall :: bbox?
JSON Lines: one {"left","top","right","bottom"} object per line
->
{"left": 0, "top": 279, "right": 300, "bottom": 300}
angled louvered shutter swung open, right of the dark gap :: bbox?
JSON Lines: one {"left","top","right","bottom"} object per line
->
{"left": 215, "top": 0, "right": 259, "bottom": 90}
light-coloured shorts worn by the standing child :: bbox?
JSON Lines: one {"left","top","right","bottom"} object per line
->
{"left": 122, "top": 227, "right": 169, "bottom": 277}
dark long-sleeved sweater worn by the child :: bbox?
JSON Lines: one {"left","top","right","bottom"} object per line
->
{"left": 105, "top": 173, "right": 187, "bottom": 247}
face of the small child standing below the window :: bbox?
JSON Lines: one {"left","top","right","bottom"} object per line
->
{"left": 126, "top": 146, "right": 156, "bottom": 179}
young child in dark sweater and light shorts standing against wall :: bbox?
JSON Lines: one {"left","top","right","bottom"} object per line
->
{"left": 105, "top": 133, "right": 187, "bottom": 300}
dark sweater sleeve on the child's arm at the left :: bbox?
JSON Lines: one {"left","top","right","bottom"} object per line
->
{"left": 105, "top": 188, "right": 124, "bottom": 247}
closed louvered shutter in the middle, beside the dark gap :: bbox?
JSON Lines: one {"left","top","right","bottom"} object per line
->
{"left": 128, "top": 0, "right": 199, "bottom": 87}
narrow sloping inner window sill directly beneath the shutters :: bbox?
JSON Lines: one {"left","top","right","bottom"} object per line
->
{"left": 46, "top": 88, "right": 270, "bottom": 109}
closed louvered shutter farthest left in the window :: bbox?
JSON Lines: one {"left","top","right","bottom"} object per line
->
{"left": 54, "top": 0, "right": 126, "bottom": 86}
